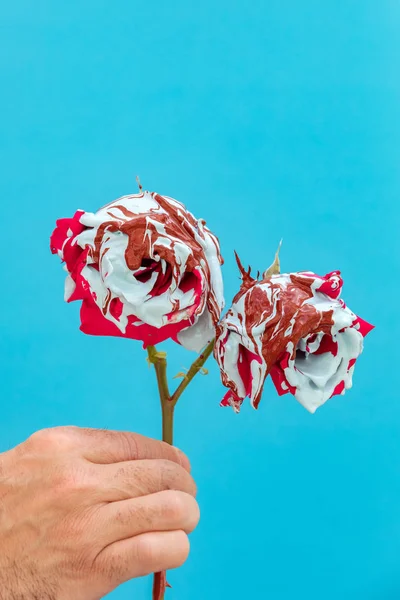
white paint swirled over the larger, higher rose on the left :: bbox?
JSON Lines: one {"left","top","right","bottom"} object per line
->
{"left": 59, "top": 192, "right": 224, "bottom": 351}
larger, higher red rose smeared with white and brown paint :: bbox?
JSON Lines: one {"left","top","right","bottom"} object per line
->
{"left": 51, "top": 192, "right": 223, "bottom": 351}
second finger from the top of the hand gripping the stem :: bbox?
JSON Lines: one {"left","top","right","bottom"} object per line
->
{"left": 96, "top": 459, "right": 196, "bottom": 502}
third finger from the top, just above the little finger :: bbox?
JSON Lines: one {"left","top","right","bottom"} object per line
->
{"left": 89, "top": 490, "right": 200, "bottom": 548}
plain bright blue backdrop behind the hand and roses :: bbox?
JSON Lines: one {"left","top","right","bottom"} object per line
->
{"left": 0, "top": 0, "right": 400, "bottom": 600}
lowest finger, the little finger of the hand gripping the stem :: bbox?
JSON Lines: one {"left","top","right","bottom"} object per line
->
{"left": 93, "top": 530, "right": 190, "bottom": 587}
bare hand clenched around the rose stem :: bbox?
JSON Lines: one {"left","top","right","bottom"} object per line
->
{"left": 0, "top": 427, "right": 199, "bottom": 600}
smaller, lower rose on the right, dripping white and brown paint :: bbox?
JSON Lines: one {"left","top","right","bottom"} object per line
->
{"left": 215, "top": 263, "right": 373, "bottom": 412}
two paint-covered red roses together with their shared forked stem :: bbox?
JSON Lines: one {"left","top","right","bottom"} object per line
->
{"left": 51, "top": 185, "right": 373, "bottom": 600}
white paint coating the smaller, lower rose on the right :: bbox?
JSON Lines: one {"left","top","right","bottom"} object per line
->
{"left": 216, "top": 272, "right": 363, "bottom": 413}
